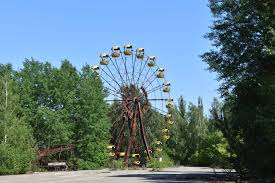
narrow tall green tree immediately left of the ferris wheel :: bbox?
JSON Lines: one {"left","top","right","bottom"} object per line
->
{"left": 75, "top": 65, "right": 110, "bottom": 169}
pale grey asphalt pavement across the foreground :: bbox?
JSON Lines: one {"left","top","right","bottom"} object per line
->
{"left": 0, "top": 167, "right": 236, "bottom": 183}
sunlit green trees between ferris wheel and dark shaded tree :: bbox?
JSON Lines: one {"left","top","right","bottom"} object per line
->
{"left": 166, "top": 96, "right": 228, "bottom": 168}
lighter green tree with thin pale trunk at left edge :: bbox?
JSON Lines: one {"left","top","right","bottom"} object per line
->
{"left": 0, "top": 65, "right": 34, "bottom": 174}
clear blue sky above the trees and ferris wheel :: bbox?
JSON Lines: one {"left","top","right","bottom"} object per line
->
{"left": 0, "top": 0, "right": 219, "bottom": 111}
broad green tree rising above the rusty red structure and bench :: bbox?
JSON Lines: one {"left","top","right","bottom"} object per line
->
{"left": 17, "top": 59, "right": 77, "bottom": 149}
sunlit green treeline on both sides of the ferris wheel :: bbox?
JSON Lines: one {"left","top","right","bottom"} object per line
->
{"left": 0, "top": 59, "right": 228, "bottom": 174}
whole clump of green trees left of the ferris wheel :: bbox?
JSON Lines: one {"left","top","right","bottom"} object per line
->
{"left": 0, "top": 59, "right": 110, "bottom": 174}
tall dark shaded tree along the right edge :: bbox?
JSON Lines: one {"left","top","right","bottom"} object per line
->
{"left": 202, "top": 0, "right": 275, "bottom": 178}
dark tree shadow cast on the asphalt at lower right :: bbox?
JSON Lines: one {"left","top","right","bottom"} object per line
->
{"left": 111, "top": 172, "right": 236, "bottom": 183}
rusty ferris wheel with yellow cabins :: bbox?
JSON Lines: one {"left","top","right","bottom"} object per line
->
{"left": 92, "top": 44, "right": 174, "bottom": 165}
